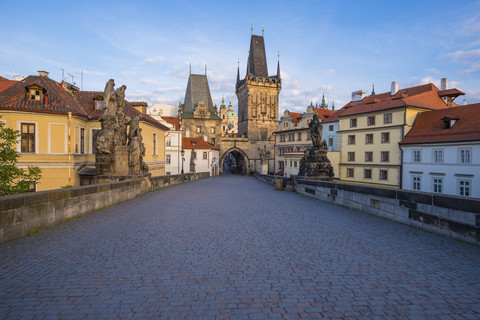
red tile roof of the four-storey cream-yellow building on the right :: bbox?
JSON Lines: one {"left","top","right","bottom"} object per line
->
{"left": 339, "top": 83, "right": 456, "bottom": 117}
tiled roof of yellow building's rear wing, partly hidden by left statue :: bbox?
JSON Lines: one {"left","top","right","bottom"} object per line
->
{"left": 74, "top": 91, "right": 170, "bottom": 131}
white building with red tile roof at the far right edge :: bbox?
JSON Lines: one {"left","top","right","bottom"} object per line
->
{"left": 400, "top": 103, "right": 480, "bottom": 198}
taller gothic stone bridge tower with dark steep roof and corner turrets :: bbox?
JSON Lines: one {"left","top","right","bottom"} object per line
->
{"left": 236, "top": 34, "right": 282, "bottom": 143}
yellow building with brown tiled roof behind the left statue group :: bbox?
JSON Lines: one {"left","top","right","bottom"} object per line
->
{"left": 0, "top": 71, "right": 168, "bottom": 191}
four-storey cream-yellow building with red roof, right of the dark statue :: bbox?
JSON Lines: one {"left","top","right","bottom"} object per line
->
{"left": 337, "top": 82, "right": 463, "bottom": 188}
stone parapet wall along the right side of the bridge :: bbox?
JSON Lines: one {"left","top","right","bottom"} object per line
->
{"left": 294, "top": 178, "right": 480, "bottom": 246}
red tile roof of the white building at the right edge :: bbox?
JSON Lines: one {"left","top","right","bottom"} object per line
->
{"left": 400, "top": 103, "right": 480, "bottom": 144}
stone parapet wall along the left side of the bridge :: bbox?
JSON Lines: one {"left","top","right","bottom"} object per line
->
{"left": 0, "top": 172, "right": 204, "bottom": 243}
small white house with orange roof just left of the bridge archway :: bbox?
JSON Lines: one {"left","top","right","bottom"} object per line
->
{"left": 182, "top": 137, "right": 220, "bottom": 176}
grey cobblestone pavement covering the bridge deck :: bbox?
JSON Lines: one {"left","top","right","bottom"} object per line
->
{"left": 0, "top": 176, "right": 480, "bottom": 319}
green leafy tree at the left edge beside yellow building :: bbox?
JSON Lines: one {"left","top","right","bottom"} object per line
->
{"left": 0, "top": 120, "right": 41, "bottom": 196}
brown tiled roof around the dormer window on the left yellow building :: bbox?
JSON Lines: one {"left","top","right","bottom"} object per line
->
{"left": 0, "top": 76, "right": 88, "bottom": 117}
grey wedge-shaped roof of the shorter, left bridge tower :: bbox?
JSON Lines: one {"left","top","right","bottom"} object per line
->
{"left": 182, "top": 74, "right": 220, "bottom": 119}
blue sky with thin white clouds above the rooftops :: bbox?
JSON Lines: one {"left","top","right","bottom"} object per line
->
{"left": 0, "top": 0, "right": 480, "bottom": 115}
